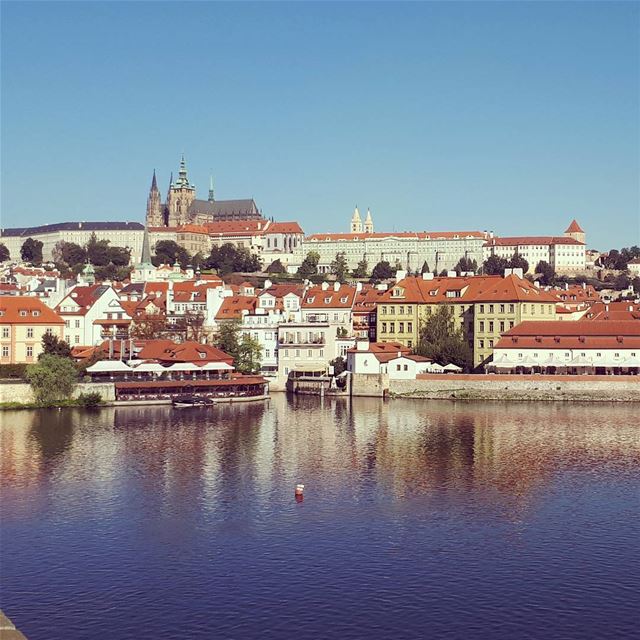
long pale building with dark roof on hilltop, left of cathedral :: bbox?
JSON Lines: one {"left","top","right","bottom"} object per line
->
{"left": 0, "top": 222, "right": 144, "bottom": 263}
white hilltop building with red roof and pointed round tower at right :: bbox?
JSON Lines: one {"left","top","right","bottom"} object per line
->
{"left": 483, "top": 220, "right": 587, "bottom": 273}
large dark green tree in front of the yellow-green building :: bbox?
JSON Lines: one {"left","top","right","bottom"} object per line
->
{"left": 416, "top": 305, "right": 473, "bottom": 371}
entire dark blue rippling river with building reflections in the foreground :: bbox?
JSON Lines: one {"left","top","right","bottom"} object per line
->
{"left": 0, "top": 394, "right": 640, "bottom": 640}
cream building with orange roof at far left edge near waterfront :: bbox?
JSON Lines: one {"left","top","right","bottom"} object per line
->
{"left": 0, "top": 296, "right": 64, "bottom": 364}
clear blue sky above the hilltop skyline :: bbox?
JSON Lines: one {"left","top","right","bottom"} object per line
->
{"left": 1, "top": 2, "right": 640, "bottom": 249}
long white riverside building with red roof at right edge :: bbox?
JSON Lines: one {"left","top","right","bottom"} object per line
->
{"left": 485, "top": 320, "right": 640, "bottom": 375}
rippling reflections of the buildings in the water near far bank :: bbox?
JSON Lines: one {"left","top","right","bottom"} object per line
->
{"left": 0, "top": 394, "right": 640, "bottom": 524}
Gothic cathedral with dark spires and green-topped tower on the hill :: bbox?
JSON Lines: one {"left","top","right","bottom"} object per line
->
{"left": 146, "top": 155, "right": 262, "bottom": 227}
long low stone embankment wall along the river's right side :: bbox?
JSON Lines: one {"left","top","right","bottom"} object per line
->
{"left": 352, "top": 374, "right": 640, "bottom": 402}
